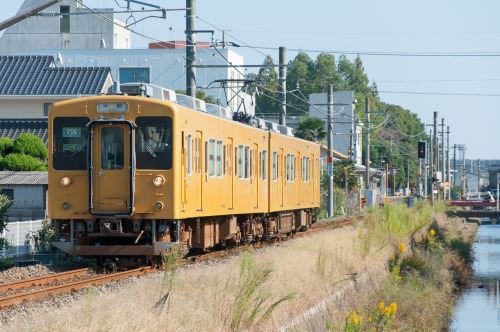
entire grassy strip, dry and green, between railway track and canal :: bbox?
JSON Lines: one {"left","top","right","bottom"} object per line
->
{"left": 0, "top": 201, "right": 472, "bottom": 331}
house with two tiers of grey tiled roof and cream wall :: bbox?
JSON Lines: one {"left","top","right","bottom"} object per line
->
{"left": 0, "top": 55, "right": 113, "bottom": 143}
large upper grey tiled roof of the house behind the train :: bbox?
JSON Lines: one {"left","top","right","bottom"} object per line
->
{"left": 0, "top": 55, "right": 110, "bottom": 96}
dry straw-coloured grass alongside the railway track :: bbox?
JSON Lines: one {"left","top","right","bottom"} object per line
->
{"left": 5, "top": 227, "right": 392, "bottom": 331}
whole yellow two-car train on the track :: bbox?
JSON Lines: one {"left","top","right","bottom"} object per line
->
{"left": 48, "top": 84, "right": 320, "bottom": 257}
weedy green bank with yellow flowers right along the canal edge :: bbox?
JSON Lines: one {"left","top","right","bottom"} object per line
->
{"left": 327, "top": 204, "right": 477, "bottom": 331}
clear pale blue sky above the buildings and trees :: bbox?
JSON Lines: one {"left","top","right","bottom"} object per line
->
{"left": 0, "top": 0, "right": 500, "bottom": 159}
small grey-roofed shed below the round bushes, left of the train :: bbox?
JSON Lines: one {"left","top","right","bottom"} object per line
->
{"left": 0, "top": 171, "right": 48, "bottom": 221}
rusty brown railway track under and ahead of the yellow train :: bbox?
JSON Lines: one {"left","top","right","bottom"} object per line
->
{"left": 0, "top": 216, "right": 361, "bottom": 310}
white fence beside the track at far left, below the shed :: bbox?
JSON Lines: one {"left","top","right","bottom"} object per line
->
{"left": 0, "top": 220, "right": 42, "bottom": 257}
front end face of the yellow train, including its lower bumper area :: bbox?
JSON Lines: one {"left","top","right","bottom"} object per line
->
{"left": 48, "top": 95, "right": 181, "bottom": 257}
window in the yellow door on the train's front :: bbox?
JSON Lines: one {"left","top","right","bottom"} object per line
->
{"left": 101, "top": 127, "right": 125, "bottom": 170}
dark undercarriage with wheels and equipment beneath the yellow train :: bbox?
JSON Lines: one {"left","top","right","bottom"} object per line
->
{"left": 52, "top": 209, "right": 316, "bottom": 258}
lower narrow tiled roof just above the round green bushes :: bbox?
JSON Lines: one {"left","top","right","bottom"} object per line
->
{"left": 0, "top": 119, "right": 49, "bottom": 145}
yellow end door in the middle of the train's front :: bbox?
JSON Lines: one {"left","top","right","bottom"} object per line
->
{"left": 90, "top": 122, "right": 133, "bottom": 215}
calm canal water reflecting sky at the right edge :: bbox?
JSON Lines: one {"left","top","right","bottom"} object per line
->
{"left": 450, "top": 225, "right": 500, "bottom": 332}
